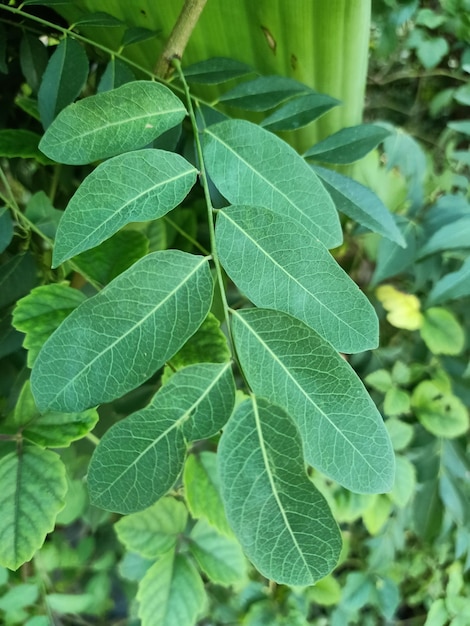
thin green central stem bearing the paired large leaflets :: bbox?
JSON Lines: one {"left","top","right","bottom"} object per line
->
{"left": 173, "top": 59, "right": 233, "bottom": 352}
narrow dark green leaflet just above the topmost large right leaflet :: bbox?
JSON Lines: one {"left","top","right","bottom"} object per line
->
{"left": 219, "top": 76, "right": 311, "bottom": 111}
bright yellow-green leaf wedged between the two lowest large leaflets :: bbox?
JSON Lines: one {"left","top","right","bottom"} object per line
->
{"left": 183, "top": 450, "right": 232, "bottom": 535}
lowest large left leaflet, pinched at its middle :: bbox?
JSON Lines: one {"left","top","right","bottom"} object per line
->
{"left": 88, "top": 363, "right": 235, "bottom": 513}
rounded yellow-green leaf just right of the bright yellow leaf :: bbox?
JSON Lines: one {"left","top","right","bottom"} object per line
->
{"left": 419, "top": 307, "right": 465, "bottom": 354}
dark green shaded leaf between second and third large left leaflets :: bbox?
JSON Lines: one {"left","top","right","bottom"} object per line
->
{"left": 74, "top": 229, "right": 149, "bottom": 285}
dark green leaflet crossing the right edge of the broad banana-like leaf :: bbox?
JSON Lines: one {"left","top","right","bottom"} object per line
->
{"left": 304, "top": 124, "right": 390, "bottom": 163}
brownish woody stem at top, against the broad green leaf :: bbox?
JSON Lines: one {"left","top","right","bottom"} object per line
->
{"left": 154, "top": 0, "right": 207, "bottom": 79}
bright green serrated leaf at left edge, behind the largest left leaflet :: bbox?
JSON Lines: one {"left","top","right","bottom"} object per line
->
{"left": 12, "top": 283, "right": 86, "bottom": 367}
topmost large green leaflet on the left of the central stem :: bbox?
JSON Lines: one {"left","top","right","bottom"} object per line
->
{"left": 39, "top": 81, "right": 186, "bottom": 165}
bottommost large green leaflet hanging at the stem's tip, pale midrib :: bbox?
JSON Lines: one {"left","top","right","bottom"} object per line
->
{"left": 218, "top": 398, "right": 341, "bottom": 585}
